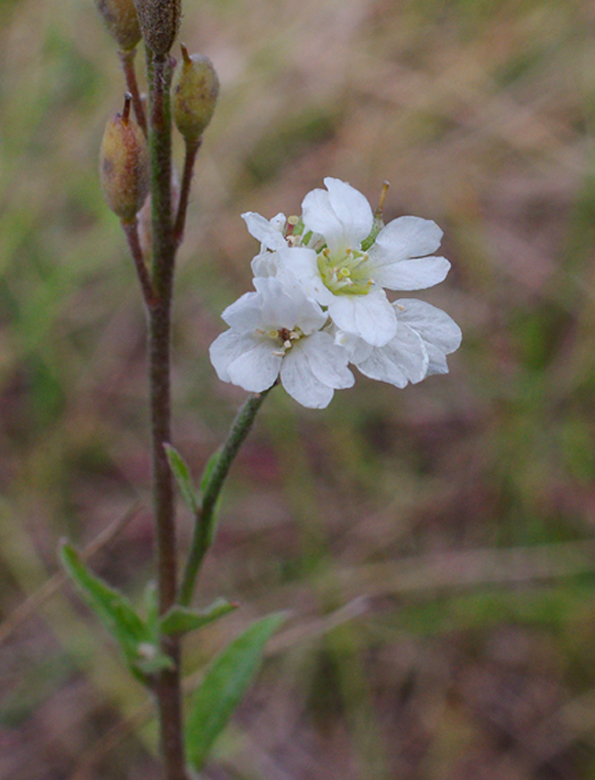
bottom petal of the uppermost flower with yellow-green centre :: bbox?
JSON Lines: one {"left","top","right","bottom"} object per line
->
{"left": 328, "top": 290, "right": 397, "bottom": 347}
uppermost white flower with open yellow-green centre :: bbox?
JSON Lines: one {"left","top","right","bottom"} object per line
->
{"left": 278, "top": 177, "right": 450, "bottom": 347}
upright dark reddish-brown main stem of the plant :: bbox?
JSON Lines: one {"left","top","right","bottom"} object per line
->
{"left": 148, "top": 50, "right": 187, "bottom": 780}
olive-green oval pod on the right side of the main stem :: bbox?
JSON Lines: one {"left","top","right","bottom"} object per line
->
{"left": 172, "top": 44, "right": 219, "bottom": 142}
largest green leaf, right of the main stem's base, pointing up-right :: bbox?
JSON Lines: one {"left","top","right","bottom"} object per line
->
{"left": 187, "top": 613, "right": 285, "bottom": 772}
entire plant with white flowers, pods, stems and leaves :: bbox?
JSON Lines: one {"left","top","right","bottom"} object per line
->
{"left": 61, "top": 0, "right": 461, "bottom": 780}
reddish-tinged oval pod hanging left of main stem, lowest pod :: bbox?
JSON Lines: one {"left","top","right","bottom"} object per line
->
{"left": 99, "top": 94, "right": 150, "bottom": 222}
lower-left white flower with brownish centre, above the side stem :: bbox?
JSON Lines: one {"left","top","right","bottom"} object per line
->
{"left": 210, "top": 277, "right": 354, "bottom": 409}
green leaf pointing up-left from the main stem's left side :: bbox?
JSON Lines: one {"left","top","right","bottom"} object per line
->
{"left": 60, "top": 544, "right": 152, "bottom": 667}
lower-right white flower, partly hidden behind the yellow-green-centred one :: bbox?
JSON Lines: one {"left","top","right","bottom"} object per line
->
{"left": 335, "top": 299, "right": 461, "bottom": 388}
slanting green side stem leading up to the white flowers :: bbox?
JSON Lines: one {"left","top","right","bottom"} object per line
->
{"left": 178, "top": 385, "right": 274, "bottom": 607}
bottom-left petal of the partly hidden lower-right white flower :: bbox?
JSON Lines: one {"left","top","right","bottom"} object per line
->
{"left": 357, "top": 324, "right": 429, "bottom": 388}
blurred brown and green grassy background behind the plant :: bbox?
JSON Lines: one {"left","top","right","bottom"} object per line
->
{"left": 0, "top": 0, "right": 595, "bottom": 780}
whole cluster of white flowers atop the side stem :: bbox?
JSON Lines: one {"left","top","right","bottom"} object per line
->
{"left": 210, "top": 177, "right": 461, "bottom": 409}
